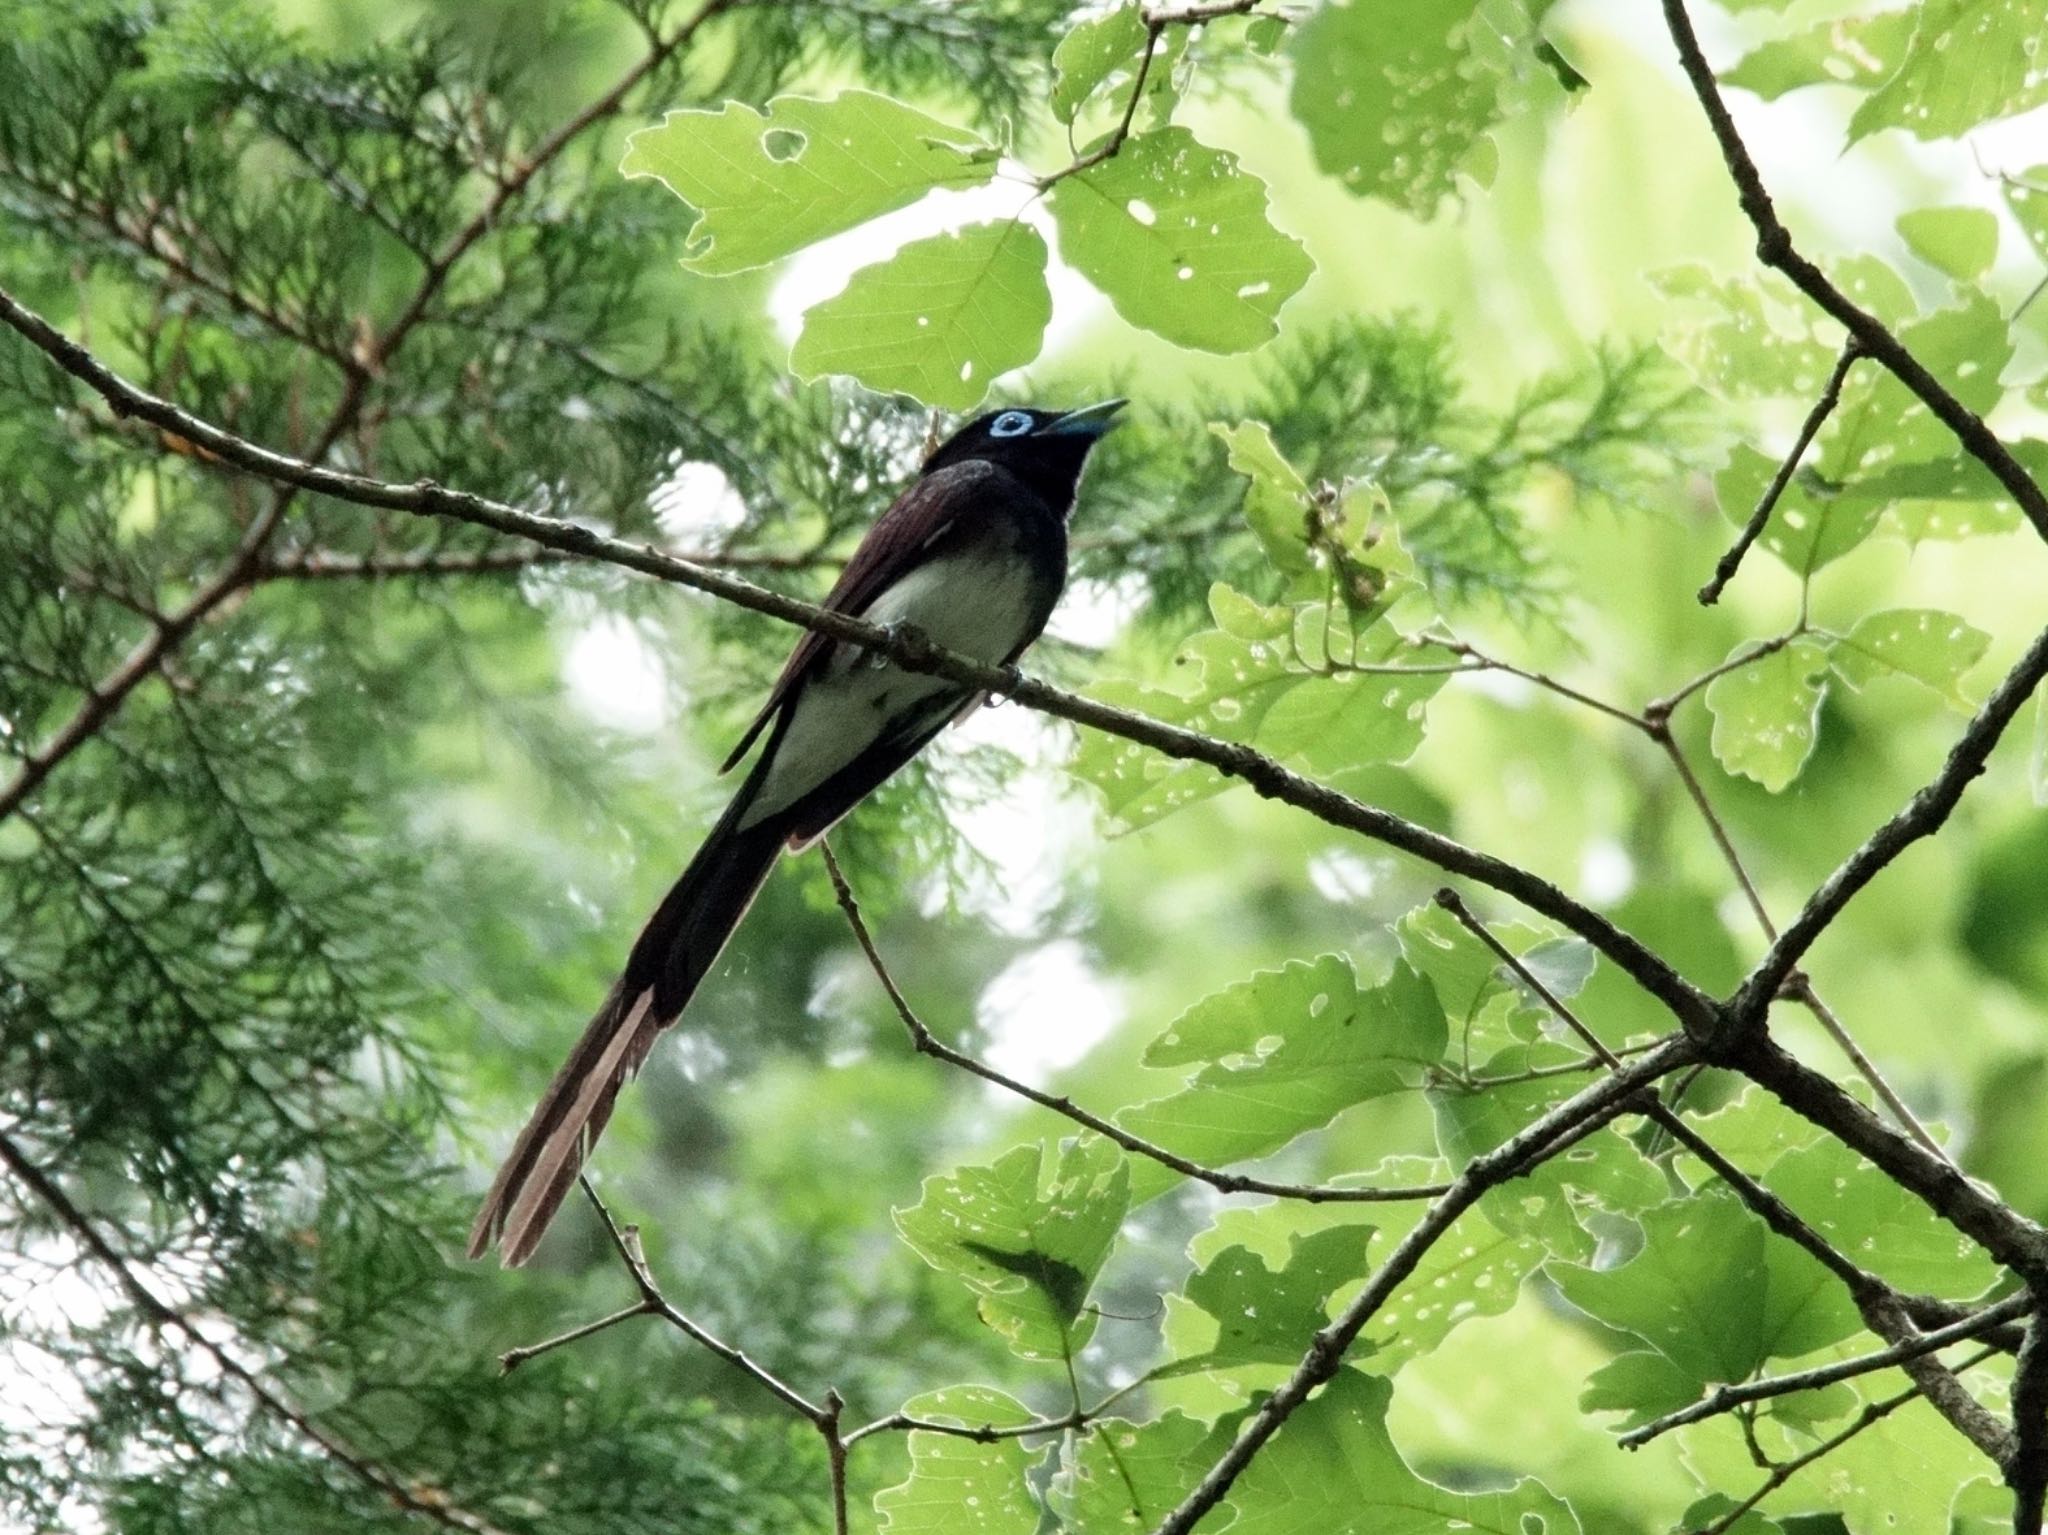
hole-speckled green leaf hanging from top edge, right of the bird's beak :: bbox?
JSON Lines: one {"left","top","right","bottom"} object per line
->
{"left": 1288, "top": 0, "right": 1528, "bottom": 219}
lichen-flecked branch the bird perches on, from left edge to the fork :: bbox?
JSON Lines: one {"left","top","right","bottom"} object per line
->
{"left": 0, "top": 291, "right": 1718, "bottom": 1036}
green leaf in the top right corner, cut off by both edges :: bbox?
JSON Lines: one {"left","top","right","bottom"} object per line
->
{"left": 1849, "top": 0, "right": 2048, "bottom": 143}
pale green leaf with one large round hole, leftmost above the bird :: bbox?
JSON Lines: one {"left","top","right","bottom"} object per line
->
{"left": 618, "top": 90, "right": 997, "bottom": 276}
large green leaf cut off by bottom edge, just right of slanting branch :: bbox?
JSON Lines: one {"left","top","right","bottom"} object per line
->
{"left": 1229, "top": 1369, "right": 1579, "bottom": 1535}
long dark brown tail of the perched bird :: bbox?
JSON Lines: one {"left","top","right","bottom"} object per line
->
{"left": 469, "top": 774, "right": 791, "bottom": 1267}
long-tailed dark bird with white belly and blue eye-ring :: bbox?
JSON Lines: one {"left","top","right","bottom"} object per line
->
{"left": 469, "top": 399, "right": 1128, "bottom": 1267}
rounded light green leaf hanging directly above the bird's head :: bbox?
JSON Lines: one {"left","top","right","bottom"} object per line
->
{"left": 788, "top": 219, "right": 1053, "bottom": 409}
